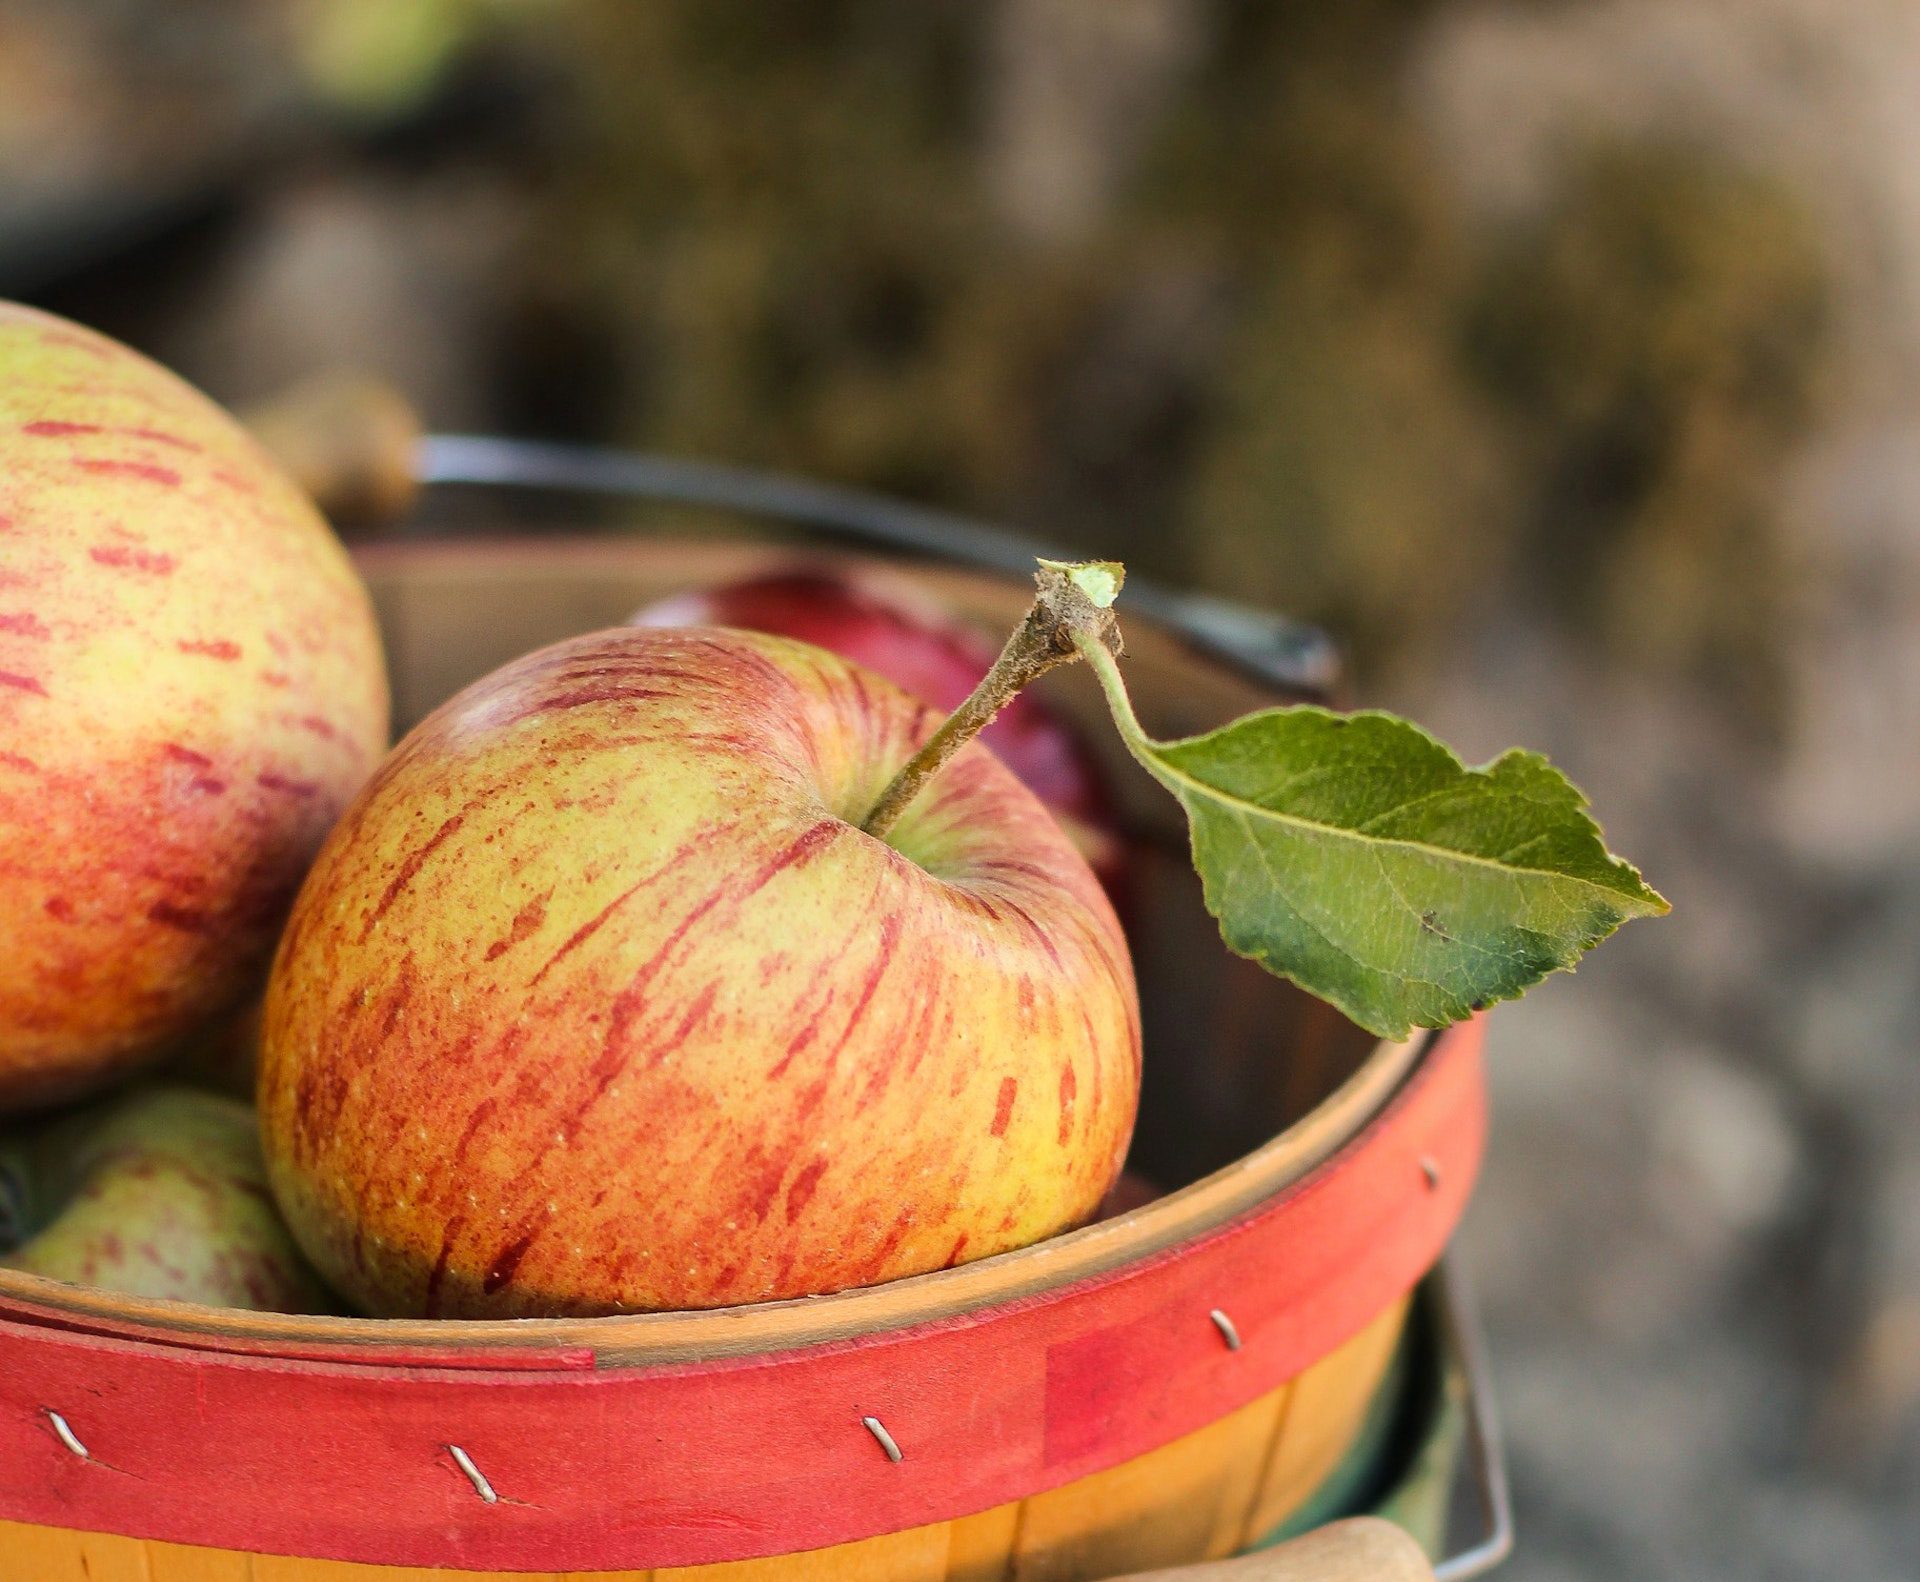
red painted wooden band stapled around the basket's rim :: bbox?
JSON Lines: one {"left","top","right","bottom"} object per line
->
{"left": 0, "top": 1021, "right": 1486, "bottom": 1570}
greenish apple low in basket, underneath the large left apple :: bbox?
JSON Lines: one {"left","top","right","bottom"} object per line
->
{"left": 0, "top": 1087, "right": 332, "bottom": 1313}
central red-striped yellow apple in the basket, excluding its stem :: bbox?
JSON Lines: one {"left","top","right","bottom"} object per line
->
{"left": 259, "top": 628, "right": 1140, "bottom": 1317}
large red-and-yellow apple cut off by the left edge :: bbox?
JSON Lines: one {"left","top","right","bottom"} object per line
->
{"left": 0, "top": 303, "right": 388, "bottom": 1112}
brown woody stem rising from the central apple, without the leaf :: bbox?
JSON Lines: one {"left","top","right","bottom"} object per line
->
{"left": 860, "top": 561, "right": 1125, "bottom": 837}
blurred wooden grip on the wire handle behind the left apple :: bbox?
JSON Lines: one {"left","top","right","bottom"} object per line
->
{"left": 240, "top": 372, "right": 420, "bottom": 524}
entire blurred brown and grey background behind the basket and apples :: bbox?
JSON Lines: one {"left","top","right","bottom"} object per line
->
{"left": 0, "top": 0, "right": 1920, "bottom": 1582}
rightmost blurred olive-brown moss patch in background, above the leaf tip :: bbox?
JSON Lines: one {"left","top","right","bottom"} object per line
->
{"left": 1473, "top": 144, "right": 1832, "bottom": 726}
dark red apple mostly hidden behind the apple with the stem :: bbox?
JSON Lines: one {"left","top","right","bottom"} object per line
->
{"left": 632, "top": 563, "right": 1125, "bottom": 893}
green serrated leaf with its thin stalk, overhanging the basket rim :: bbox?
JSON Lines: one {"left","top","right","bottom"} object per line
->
{"left": 1079, "top": 641, "right": 1667, "bottom": 1039}
